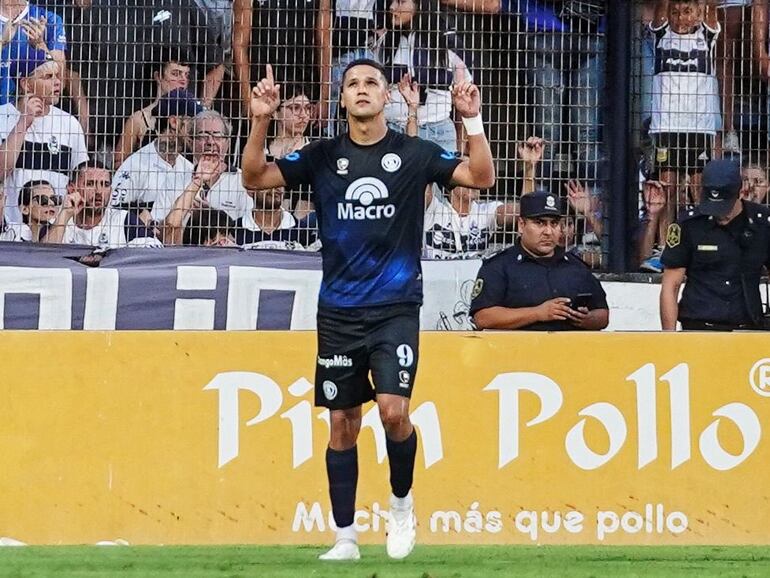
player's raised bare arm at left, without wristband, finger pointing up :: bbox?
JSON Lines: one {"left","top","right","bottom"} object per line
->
{"left": 243, "top": 64, "right": 286, "bottom": 191}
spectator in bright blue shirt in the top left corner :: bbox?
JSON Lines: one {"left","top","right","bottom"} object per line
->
{"left": 0, "top": 0, "right": 67, "bottom": 104}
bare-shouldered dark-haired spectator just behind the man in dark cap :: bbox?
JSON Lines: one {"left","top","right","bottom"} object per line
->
{"left": 113, "top": 54, "right": 190, "bottom": 167}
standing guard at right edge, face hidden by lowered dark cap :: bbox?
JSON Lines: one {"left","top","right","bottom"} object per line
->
{"left": 660, "top": 160, "right": 770, "bottom": 331}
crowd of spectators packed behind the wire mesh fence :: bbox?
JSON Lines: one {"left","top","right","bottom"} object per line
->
{"left": 0, "top": 0, "right": 770, "bottom": 271}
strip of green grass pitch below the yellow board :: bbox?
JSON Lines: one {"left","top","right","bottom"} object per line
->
{"left": 0, "top": 546, "right": 770, "bottom": 578}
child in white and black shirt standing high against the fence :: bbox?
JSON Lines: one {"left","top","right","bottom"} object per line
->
{"left": 650, "top": 0, "right": 721, "bottom": 232}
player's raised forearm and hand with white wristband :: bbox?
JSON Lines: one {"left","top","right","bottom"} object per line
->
{"left": 452, "top": 81, "right": 495, "bottom": 189}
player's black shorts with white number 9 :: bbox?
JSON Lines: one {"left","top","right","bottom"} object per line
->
{"left": 315, "top": 303, "right": 420, "bottom": 409}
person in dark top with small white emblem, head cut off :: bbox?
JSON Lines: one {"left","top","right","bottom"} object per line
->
{"left": 70, "top": 0, "right": 224, "bottom": 151}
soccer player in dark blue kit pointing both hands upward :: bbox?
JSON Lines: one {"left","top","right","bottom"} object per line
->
{"left": 243, "top": 60, "right": 495, "bottom": 560}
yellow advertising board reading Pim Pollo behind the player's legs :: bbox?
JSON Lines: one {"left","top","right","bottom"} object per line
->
{"left": 0, "top": 332, "right": 770, "bottom": 544}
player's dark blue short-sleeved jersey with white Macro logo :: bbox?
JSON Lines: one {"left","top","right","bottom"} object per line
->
{"left": 276, "top": 130, "right": 460, "bottom": 307}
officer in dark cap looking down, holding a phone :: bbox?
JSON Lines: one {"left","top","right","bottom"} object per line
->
{"left": 470, "top": 191, "right": 609, "bottom": 331}
